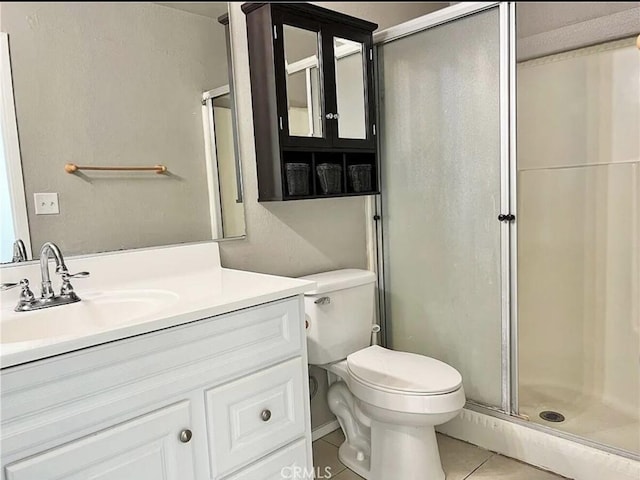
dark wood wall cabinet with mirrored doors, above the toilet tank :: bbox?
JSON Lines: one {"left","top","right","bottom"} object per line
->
{"left": 242, "top": 3, "right": 379, "bottom": 202}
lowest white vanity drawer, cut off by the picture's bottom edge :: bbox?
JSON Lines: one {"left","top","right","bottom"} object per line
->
{"left": 225, "top": 440, "right": 314, "bottom": 480}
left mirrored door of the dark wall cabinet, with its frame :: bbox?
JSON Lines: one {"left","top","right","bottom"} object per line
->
{"left": 273, "top": 10, "right": 332, "bottom": 147}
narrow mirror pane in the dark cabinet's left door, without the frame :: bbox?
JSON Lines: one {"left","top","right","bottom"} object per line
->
{"left": 283, "top": 25, "right": 324, "bottom": 138}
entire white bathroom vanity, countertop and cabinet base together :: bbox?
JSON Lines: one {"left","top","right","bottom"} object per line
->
{"left": 0, "top": 243, "right": 314, "bottom": 480}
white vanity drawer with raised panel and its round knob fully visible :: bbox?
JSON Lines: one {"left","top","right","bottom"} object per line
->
{"left": 205, "top": 357, "right": 308, "bottom": 478}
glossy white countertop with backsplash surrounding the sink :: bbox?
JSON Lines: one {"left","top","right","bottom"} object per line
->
{"left": 0, "top": 243, "right": 316, "bottom": 368}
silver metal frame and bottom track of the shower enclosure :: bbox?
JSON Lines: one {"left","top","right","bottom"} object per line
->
{"left": 367, "top": 2, "right": 640, "bottom": 460}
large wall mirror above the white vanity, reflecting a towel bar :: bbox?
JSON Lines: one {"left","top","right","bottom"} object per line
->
{"left": 0, "top": 2, "right": 245, "bottom": 262}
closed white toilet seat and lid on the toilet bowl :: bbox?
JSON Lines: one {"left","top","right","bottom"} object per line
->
{"left": 347, "top": 345, "right": 462, "bottom": 396}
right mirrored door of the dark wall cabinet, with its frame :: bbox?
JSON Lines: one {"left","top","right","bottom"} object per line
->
{"left": 322, "top": 25, "right": 375, "bottom": 149}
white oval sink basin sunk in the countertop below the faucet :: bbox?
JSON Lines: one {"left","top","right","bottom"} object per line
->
{"left": 0, "top": 289, "right": 179, "bottom": 344}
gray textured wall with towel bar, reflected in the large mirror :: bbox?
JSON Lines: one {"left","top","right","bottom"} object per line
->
{"left": 0, "top": 2, "right": 228, "bottom": 254}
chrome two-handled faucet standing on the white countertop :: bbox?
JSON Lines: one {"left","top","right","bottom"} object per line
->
{"left": 1, "top": 242, "right": 89, "bottom": 312}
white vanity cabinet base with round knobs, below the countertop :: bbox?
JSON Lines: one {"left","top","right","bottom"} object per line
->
{"left": 1, "top": 296, "right": 312, "bottom": 480}
